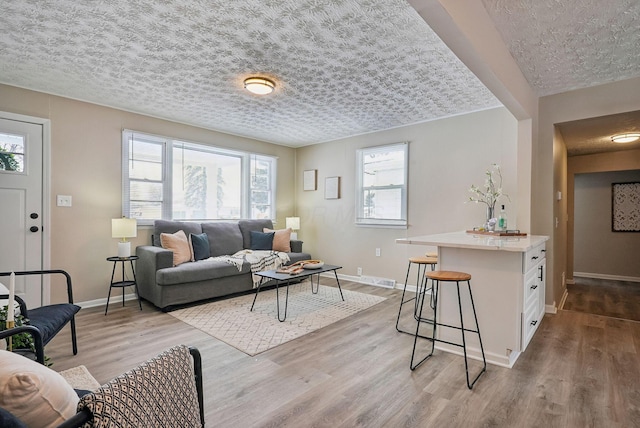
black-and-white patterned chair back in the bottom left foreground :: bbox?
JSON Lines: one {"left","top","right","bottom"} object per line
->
{"left": 78, "top": 345, "right": 202, "bottom": 428}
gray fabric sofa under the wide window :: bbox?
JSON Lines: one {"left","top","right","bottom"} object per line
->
{"left": 136, "top": 220, "right": 311, "bottom": 311}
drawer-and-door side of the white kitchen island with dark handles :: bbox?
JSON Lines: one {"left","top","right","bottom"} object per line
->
{"left": 520, "top": 244, "right": 546, "bottom": 351}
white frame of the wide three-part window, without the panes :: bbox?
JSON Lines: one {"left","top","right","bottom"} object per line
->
{"left": 122, "top": 129, "right": 278, "bottom": 225}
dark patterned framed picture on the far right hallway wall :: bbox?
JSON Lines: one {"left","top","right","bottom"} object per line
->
{"left": 611, "top": 181, "right": 640, "bottom": 232}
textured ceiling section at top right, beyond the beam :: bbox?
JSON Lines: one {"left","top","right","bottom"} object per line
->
{"left": 482, "top": 0, "right": 640, "bottom": 96}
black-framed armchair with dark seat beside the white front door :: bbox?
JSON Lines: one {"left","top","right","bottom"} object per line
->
{"left": 0, "top": 269, "right": 80, "bottom": 355}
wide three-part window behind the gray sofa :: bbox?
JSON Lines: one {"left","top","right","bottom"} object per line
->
{"left": 122, "top": 130, "right": 276, "bottom": 224}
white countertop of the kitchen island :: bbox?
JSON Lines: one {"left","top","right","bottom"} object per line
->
{"left": 396, "top": 231, "right": 549, "bottom": 253}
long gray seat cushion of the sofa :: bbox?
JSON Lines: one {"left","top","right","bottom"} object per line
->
{"left": 156, "top": 260, "right": 251, "bottom": 286}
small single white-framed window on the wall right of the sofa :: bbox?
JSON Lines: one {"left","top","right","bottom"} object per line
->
{"left": 356, "top": 143, "right": 409, "bottom": 227}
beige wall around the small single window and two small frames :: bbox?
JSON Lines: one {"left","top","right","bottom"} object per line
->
{"left": 296, "top": 108, "right": 529, "bottom": 283}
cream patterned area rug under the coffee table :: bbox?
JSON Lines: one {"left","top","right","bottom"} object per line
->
{"left": 169, "top": 281, "right": 385, "bottom": 356}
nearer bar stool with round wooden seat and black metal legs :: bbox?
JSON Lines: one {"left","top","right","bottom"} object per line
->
{"left": 410, "top": 271, "right": 487, "bottom": 389}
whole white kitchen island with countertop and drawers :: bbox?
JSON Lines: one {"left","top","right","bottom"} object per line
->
{"left": 396, "top": 231, "right": 549, "bottom": 368}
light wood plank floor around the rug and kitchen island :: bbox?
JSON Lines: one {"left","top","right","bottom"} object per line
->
{"left": 46, "top": 282, "right": 640, "bottom": 428}
